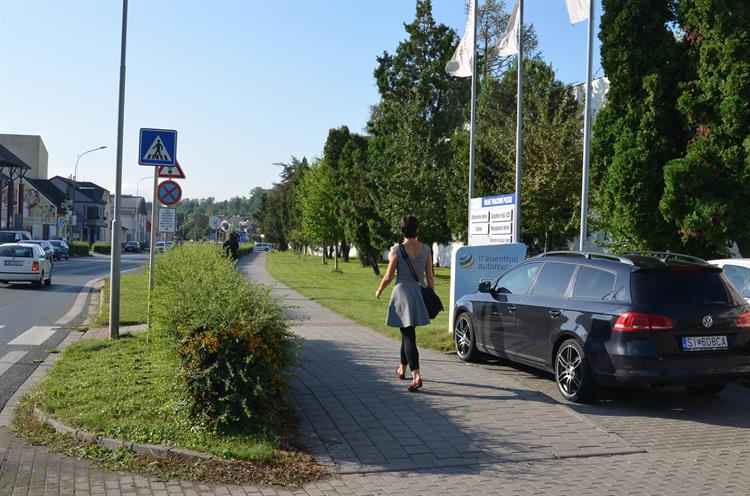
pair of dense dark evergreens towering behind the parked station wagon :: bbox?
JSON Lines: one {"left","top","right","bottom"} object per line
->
{"left": 592, "top": 0, "right": 750, "bottom": 257}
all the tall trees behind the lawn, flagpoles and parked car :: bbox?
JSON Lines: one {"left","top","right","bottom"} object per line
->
{"left": 256, "top": 0, "right": 750, "bottom": 273}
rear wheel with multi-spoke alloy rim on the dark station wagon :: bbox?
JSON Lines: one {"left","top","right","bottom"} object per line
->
{"left": 554, "top": 339, "right": 596, "bottom": 403}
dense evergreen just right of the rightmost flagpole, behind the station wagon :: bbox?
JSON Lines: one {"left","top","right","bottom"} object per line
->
{"left": 592, "top": 0, "right": 687, "bottom": 249}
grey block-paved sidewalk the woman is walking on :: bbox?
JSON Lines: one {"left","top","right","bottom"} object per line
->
{"left": 0, "top": 254, "right": 750, "bottom": 496}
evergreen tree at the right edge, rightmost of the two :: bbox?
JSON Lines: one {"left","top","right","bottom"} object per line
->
{"left": 661, "top": 0, "right": 750, "bottom": 257}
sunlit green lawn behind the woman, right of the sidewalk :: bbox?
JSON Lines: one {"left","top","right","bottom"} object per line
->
{"left": 268, "top": 252, "right": 453, "bottom": 351}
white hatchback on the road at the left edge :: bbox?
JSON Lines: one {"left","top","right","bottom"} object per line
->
{"left": 0, "top": 243, "right": 52, "bottom": 288}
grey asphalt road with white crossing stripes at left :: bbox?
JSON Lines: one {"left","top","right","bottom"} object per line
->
{"left": 0, "top": 254, "right": 148, "bottom": 409}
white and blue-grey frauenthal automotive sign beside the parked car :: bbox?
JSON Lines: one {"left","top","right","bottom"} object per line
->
{"left": 448, "top": 244, "right": 526, "bottom": 332}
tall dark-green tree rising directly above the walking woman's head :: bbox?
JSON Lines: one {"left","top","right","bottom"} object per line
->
{"left": 368, "top": 0, "right": 470, "bottom": 243}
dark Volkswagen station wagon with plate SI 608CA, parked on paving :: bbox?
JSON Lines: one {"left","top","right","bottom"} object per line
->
{"left": 454, "top": 252, "right": 750, "bottom": 402}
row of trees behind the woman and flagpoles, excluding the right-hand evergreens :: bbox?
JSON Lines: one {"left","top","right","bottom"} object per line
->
{"left": 257, "top": 0, "right": 581, "bottom": 273}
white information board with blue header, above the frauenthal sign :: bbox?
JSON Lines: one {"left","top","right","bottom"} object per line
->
{"left": 469, "top": 194, "right": 516, "bottom": 246}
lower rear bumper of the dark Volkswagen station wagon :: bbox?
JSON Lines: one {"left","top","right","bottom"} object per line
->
{"left": 592, "top": 354, "right": 750, "bottom": 386}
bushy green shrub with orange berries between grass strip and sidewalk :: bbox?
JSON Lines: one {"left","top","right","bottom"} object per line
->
{"left": 152, "top": 243, "right": 298, "bottom": 428}
